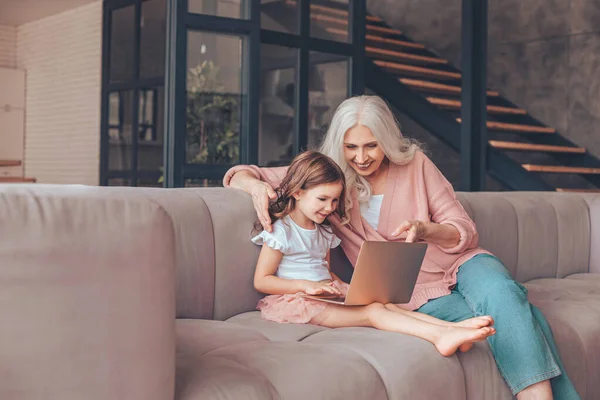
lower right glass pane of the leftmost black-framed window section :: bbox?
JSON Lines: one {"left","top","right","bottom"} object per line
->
{"left": 138, "top": 86, "right": 164, "bottom": 171}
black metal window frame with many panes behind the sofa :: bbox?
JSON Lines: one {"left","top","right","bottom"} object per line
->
{"left": 100, "top": 0, "right": 366, "bottom": 187}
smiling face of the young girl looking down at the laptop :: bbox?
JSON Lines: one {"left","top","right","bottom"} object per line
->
{"left": 294, "top": 182, "right": 343, "bottom": 224}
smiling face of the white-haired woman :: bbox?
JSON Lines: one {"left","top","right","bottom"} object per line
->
{"left": 344, "top": 125, "right": 385, "bottom": 177}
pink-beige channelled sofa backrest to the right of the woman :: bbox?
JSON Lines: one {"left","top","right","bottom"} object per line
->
{"left": 458, "top": 192, "right": 600, "bottom": 282}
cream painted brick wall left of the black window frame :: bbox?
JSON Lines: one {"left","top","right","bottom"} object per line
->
{"left": 15, "top": 1, "right": 102, "bottom": 185}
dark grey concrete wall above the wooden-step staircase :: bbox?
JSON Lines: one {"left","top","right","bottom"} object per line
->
{"left": 367, "top": 0, "right": 600, "bottom": 157}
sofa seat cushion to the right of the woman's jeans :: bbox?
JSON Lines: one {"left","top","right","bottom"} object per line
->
{"left": 525, "top": 273, "right": 600, "bottom": 399}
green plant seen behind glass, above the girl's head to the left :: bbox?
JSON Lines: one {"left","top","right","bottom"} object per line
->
{"left": 186, "top": 61, "right": 240, "bottom": 164}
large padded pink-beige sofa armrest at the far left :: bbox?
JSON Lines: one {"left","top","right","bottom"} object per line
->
{"left": 0, "top": 186, "right": 175, "bottom": 400}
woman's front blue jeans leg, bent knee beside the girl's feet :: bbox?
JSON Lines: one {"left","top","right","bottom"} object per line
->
{"left": 456, "top": 254, "right": 578, "bottom": 400}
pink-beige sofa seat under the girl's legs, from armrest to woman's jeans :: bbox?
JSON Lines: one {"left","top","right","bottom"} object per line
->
{"left": 176, "top": 312, "right": 512, "bottom": 400}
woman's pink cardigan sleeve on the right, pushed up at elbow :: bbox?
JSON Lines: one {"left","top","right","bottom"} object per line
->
{"left": 423, "top": 157, "right": 479, "bottom": 254}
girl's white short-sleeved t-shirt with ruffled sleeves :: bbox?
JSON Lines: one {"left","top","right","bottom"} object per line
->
{"left": 252, "top": 215, "right": 340, "bottom": 281}
